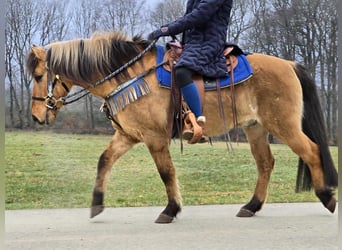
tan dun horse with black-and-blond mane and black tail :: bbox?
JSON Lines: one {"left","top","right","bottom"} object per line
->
{"left": 27, "top": 31, "right": 337, "bottom": 223}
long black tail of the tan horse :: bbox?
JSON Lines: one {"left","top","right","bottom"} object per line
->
{"left": 294, "top": 64, "right": 338, "bottom": 192}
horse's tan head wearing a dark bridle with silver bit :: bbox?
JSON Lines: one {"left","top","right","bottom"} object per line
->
{"left": 27, "top": 45, "right": 72, "bottom": 124}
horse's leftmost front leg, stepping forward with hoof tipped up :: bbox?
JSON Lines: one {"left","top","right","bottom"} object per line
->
{"left": 90, "top": 131, "right": 137, "bottom": 218}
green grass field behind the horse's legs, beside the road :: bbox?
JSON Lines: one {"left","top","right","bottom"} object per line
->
{"left": 5, "top": 132, "right": 337, "bottom": 209}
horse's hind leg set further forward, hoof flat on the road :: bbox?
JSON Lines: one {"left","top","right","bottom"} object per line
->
{"left": 237, "top": 125, "right": 274, "bottom": 217}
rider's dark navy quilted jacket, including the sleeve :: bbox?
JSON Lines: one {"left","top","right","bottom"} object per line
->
{"left": 165, "top": 0, "right": 232, "bottom": 77}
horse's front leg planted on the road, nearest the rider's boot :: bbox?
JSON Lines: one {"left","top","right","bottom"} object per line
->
{"left": 145, "top": 137, "right": 182, "bottom": 223}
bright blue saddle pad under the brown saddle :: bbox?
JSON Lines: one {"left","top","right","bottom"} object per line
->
{"left": 156, "top": 45, "right": 253, "bottom": 90}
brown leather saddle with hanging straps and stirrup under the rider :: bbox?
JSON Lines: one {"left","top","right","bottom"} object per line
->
{"left": 163, "top": 40, "right": 243, "bottom": 144}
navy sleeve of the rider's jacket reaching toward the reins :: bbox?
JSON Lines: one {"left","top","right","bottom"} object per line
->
{"left": 163, "top": 0, "right": 229, "bottom": 35}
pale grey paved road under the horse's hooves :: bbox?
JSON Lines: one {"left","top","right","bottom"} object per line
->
{"left": 5, "top": 203, "right": 338, "bottom": 250}
